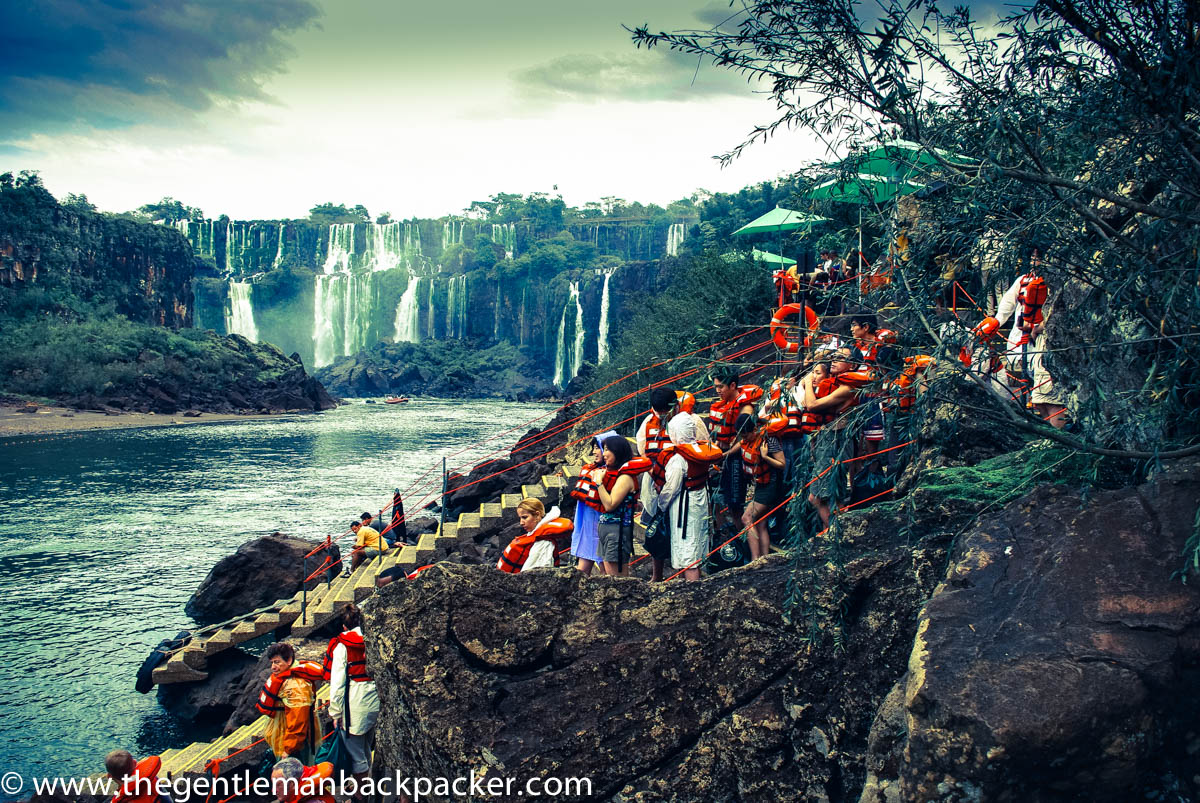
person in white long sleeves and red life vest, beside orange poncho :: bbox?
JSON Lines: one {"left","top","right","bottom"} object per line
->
{"left": 323, "top": 603, "right": 379, "bottom": 801}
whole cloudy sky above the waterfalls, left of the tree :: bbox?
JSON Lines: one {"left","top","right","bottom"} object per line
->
{"left": 0, "top": 0, "right": 840, "bottom": 218}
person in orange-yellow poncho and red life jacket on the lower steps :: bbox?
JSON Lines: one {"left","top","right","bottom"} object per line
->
{"left": 256, "top": 641, "right": 324, "bottom": 762}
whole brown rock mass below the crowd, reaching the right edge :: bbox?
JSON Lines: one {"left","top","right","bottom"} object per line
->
{"left": 366, "top": 448, "right": 1200, "bottom": 803}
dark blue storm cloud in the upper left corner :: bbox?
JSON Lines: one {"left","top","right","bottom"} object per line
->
{"left": 0, "top": 0, "right": 318, "bottom": 143}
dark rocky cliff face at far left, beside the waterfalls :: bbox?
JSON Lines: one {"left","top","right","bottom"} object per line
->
{"left": 0, "top": 184, "right": 196, "bottom": 329}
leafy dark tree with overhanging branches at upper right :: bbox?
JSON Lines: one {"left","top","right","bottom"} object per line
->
{"left": 632, "top": 0, "right": 1200, "bottom": 459}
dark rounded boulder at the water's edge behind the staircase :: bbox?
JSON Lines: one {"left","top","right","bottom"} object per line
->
{"left": 185, "top": 533, "right": 341, "bottom": 624}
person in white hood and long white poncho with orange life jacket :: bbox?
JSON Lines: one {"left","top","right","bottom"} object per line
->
{"left": 658, "top": 413, "right": 722, "bottom": 581}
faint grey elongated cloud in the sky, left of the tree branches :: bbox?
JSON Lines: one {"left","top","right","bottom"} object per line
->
{"left": 512, "top": 49, "right": 750, "bottom": 103}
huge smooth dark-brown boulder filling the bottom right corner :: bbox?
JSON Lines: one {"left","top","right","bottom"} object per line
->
{"left": 876, "top": 453, "right": 1200, "bottom": 801}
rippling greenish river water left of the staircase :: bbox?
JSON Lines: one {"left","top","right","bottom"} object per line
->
{"left": 0, "top": 398, "right": 552, "bottom": 799}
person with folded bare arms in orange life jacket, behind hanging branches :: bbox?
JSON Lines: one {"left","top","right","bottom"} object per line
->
{"left": 804, "top": 348, "right": 858, "bottom": 527}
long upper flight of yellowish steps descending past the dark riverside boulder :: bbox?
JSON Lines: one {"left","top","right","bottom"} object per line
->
{"left": 152, "top": 466, "right": 578, "bottom": 684}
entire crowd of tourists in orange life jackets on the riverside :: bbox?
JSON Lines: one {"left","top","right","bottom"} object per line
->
{"left": 106, "top": 253, "right": 1067, "bottom": 803}
